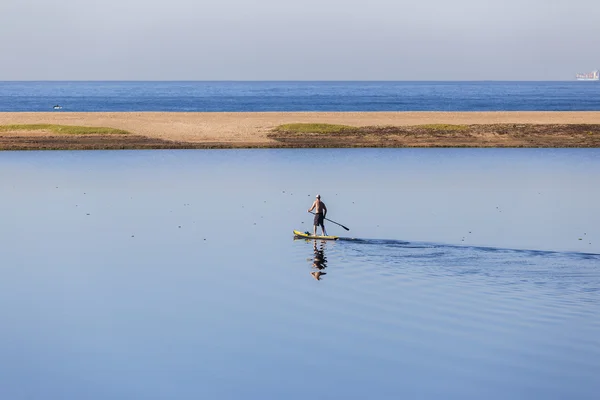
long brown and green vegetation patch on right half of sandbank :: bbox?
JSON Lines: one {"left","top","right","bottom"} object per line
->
{"left": 267, "top": 123, "right": 600, "bottom": 148}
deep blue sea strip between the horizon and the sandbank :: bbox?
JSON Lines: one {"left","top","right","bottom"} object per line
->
{"left": 0, "top": 81, "right": 600, "bottom": 112}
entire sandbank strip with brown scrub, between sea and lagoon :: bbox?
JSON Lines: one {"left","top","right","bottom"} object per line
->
{"left": 0, "top": 111, "right": 600, "bottom": 150}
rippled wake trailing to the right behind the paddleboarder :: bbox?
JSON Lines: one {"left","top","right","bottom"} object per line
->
{"left": 296, "top": 237, "right": 600, "bottom": 298}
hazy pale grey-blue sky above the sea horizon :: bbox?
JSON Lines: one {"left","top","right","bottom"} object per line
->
{"left": 0, "top": 0, "right": 600, "bottom": 80}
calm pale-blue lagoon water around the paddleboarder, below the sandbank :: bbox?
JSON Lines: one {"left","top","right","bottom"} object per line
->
{"left": 0, "top": 149, "right": 600, "bottom": 399}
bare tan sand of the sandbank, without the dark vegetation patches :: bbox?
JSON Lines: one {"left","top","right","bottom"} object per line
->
{"left": 0, "top": 111, "right": 600, "bottom": 149}
